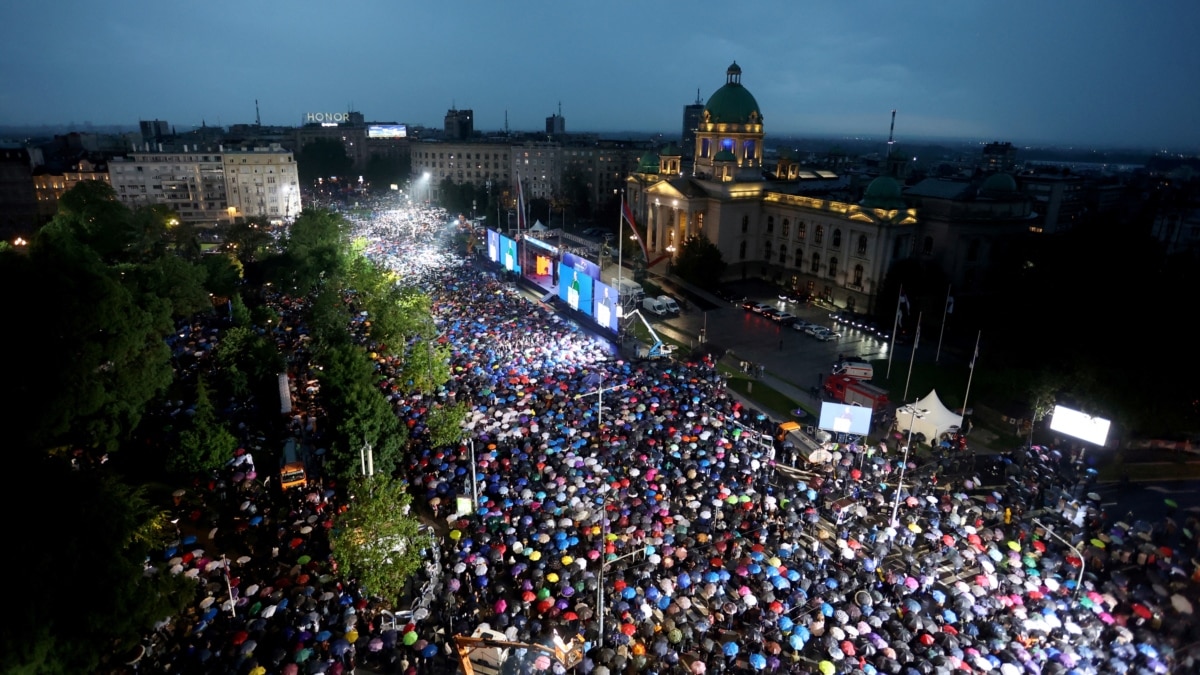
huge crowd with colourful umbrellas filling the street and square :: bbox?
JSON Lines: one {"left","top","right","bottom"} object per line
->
{"left": 126, "top": 195, "right": 1200, "bottom": 675}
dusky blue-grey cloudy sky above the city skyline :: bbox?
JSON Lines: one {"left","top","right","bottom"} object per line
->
{"left": 0, "top": 0, "right": 1200, "bottom": 147}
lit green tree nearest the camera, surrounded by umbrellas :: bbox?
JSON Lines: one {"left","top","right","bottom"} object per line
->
{"left": 329, "top": 473, "right": 433, "bottom": 603}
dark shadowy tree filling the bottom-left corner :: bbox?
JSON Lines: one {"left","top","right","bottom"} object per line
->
{"left": 0, "top": 458, "right": 196, "bottom": 673}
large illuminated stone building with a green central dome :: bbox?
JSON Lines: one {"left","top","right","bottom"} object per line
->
{"left": 625, "top": 62, "right": 1031, "bottom": 312}
